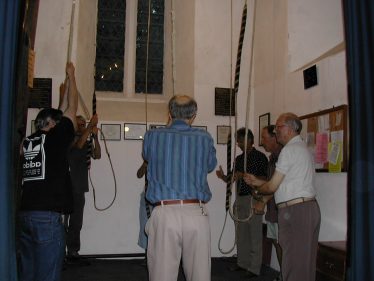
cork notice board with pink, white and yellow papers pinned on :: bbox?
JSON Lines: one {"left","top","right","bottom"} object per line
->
{"left": 299, "top": 105, "right": 348, "bottom": 173}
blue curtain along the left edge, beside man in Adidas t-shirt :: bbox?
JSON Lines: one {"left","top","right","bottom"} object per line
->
{"left": 0, "top": 0, "right": 20, "bottom": 281}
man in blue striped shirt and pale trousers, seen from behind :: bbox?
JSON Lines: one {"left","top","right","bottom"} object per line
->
{"left": 143, "top": 96, "right": 217, "bottom": 281}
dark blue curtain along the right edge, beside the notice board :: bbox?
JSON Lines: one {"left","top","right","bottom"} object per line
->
{"left": 343, "top": 0, "right": 374, "bottom": 281}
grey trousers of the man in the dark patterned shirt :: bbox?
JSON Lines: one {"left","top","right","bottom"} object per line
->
{"left": 234, "top": 195, "right": 262, "bottom": 275}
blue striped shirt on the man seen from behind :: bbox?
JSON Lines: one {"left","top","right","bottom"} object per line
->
{"left": 143, "top": 120, "right": 217, "bottom": 203}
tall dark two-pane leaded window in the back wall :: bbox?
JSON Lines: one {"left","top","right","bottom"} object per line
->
{"left": 95, "top": 0, "right": 164, "bottom": 94}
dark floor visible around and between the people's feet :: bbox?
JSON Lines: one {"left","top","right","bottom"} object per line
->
{"left": 62, "top": 257, "right": 278, "bottom": 281}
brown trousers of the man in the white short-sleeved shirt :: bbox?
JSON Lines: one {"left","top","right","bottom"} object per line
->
{"left": 278, "top": 201, "right": 321, "bottom": 281}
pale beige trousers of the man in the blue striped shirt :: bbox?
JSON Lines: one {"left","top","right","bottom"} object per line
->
{"left": 145, "top": 203, "right": 211, "bottom": 281}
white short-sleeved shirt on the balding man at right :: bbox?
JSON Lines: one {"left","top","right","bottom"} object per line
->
{"left": 274, "top": 136, "right": 316, "bottom": 204}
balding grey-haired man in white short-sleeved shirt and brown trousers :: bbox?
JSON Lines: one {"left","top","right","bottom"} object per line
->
{"left": 244, "top": 113, "right": 321, "bottom": 281}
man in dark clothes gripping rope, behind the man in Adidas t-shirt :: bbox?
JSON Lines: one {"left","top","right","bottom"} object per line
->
{"left": 65, "top": 114, "right": 101, "bottom": 260}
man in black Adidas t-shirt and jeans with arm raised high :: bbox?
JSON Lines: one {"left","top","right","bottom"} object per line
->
{"left": 19, "top": 63, "right": 78, "bottom": 281}
